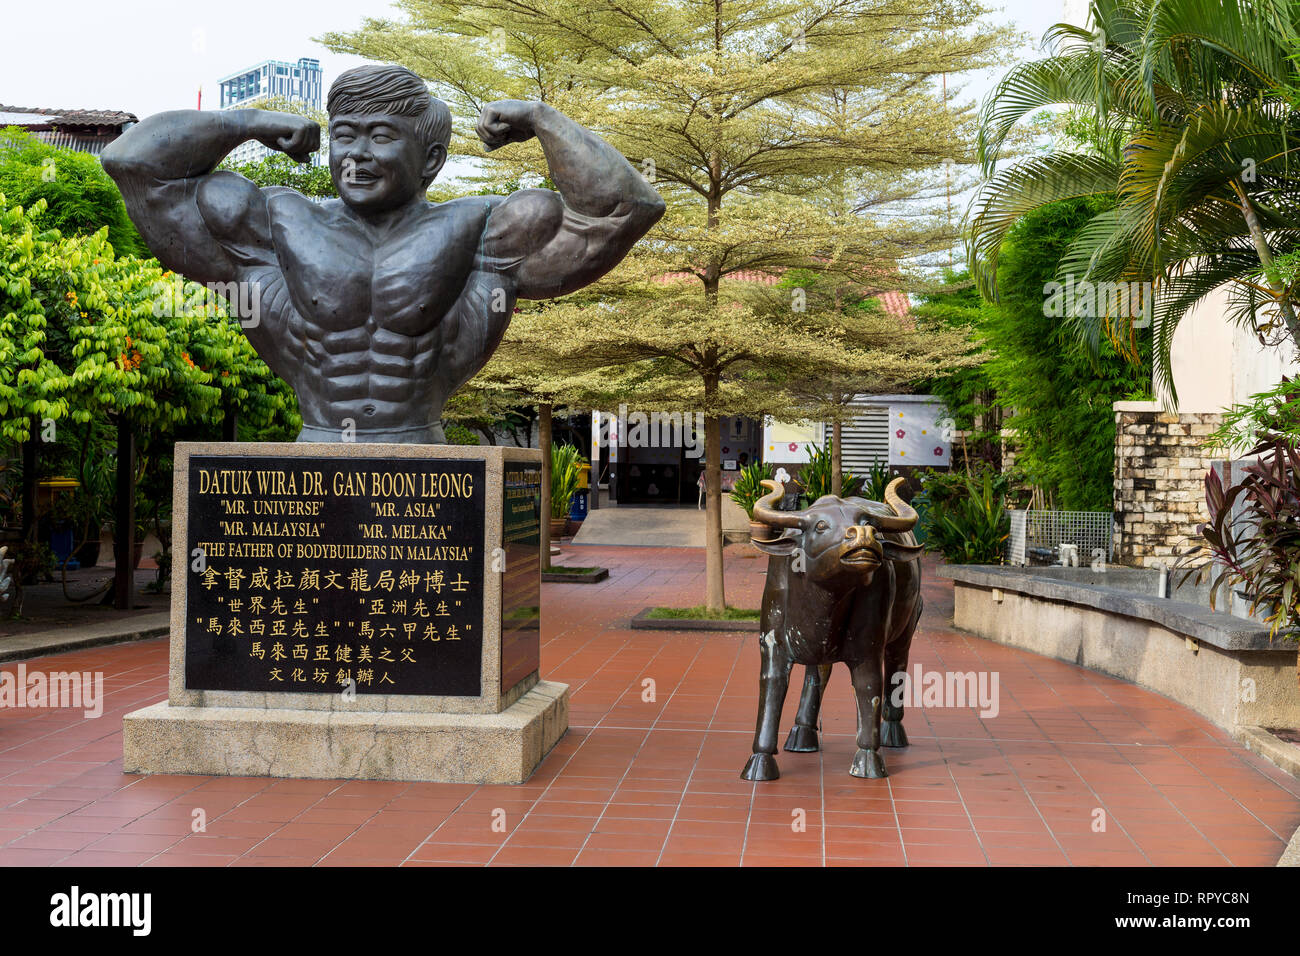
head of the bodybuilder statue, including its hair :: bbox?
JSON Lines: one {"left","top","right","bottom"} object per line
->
{"left": 326, "top": 64, "right": 451, "bottom": 212}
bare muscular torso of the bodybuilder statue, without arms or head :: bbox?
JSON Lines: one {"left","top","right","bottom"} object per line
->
{"left": 231, "top": 190, "right": 515, "bottom": 441}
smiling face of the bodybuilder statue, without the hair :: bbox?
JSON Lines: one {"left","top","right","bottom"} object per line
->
{"left": 329, "top": 113, "right": 446, "bottom": 212}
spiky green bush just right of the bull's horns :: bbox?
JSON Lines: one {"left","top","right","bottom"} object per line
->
{"left": 918, "top": 470, "right": 1011, "bottom": 564}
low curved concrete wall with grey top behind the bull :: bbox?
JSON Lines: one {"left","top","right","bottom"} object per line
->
{"left": 939, "top": 566, "right": 1300, "bottom": 735}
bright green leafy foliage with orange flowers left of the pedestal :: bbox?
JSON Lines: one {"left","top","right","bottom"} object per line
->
{"left": 0, "top": 195, "right": 300, "bottom": 598}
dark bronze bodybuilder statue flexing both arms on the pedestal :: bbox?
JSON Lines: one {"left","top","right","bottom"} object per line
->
{"left": 103, "top": 65, "right": 664, "bottom": 442}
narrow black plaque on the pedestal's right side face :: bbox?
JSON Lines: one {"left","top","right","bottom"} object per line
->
{"left": 499, "top": 460, "right": 542, "bottom": 693}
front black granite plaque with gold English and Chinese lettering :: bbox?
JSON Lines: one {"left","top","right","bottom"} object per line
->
{"left": 185, "top": 457, "right": 485, "bottom": 697}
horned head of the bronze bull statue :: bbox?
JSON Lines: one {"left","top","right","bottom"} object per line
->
{"left": 753, "top": 477, "right": 922, "bottom": 587}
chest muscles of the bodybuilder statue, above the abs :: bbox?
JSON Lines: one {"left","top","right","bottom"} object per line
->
{"left": 272, "top": 205, "right": 473, "bottom": 336}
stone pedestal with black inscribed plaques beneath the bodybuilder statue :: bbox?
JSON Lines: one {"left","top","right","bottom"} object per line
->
{"left": 122, "top": 442, "right": 568, "bottom": 783}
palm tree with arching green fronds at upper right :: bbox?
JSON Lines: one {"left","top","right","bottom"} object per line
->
{"left": 967, "top": 0, "right": 1300, "bottom": 395}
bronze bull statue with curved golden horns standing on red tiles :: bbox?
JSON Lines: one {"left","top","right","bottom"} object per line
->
{"left": 741, "top": 477, "right": 922, "bottom": 780}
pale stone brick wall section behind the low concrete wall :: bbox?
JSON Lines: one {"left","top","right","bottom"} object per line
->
{"left": 1114, "top": 402, "right": 1222, "bottom": 567}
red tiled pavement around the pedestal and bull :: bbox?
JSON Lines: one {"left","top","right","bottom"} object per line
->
{"left": 0, "top": 546, "right": 1300, "bottom": 866}
